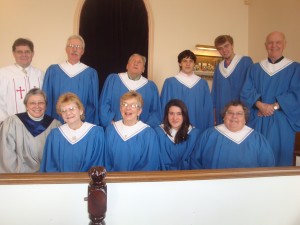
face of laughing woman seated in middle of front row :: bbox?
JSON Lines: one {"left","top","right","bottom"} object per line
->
{"left": 120, "top": 98, "right": 142, "bottom": 126}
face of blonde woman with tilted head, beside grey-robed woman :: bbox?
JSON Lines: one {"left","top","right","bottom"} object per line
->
{"left": 60, "top": 102, "right": 83, "bottom": 127}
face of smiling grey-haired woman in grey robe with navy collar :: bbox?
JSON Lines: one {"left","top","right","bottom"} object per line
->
{"left": 26, "top": 94, "right": 46, "bottom": 118}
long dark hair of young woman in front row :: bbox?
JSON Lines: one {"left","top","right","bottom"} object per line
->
{"left": 163, "top": 99, "right": 191, "bottom": 144}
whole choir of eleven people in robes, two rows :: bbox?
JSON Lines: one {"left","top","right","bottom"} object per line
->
{"left": 0, "top": 31, "right": 300, "bottom": 173}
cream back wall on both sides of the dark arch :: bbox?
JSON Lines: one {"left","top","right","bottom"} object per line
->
{"left": 0, "top": 0, "right": 248, "bottom": 89}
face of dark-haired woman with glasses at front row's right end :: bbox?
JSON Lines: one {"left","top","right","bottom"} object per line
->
{"left": 224, "top": 105, "right": 246, "bottom": 132}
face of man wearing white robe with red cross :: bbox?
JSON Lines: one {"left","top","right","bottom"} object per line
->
{"left": 13, "top": 45, "right": 34, "bottom": 68}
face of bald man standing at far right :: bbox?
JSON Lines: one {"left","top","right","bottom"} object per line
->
{"left": 265, "top": 32, "right": 286, "bottom": 60}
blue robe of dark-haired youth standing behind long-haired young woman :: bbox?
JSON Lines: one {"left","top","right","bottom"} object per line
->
{"left": 161, "top": 72, "right": 214, "bottom": 132}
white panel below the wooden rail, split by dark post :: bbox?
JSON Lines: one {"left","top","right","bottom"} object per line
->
{"left": 0, "top": 176, "right": 300, "bottom": 225}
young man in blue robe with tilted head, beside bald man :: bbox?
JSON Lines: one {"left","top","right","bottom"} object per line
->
{"left": 212, "top": 35, "right": 253, "bottom": 125}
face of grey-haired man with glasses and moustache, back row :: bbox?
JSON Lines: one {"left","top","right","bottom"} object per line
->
{"left": 66, "top": 39, "right": 84, "bottom": 64}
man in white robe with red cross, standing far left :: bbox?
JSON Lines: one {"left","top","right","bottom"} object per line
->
{"left": 0, "top": 38, "right": 44, "bottom": 123}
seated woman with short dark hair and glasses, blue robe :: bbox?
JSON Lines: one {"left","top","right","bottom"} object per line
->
{"left": 190, "top": 101, "right": 275, "bottom": 169}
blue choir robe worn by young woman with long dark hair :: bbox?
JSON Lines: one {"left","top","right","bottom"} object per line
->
{"left": 155, "top": 124, "right": 200, "bottom": 170}
